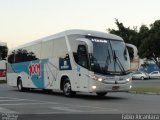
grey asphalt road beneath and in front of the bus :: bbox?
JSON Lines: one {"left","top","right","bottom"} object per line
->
{"left": 0, "top": 81, "right": 160, "bottom": 120}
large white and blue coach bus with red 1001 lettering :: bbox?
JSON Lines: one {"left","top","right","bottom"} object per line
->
{"left": 7, "top": 29, "right": 136, "bottom": 96}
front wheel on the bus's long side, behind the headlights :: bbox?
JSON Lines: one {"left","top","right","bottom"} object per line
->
{"left": 63, "top": 79, "right": 75, "bottom": 97}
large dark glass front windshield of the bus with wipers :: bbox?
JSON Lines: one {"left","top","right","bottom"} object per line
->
{"left": 89, "top": 38, "right": 130, "bottom": 75}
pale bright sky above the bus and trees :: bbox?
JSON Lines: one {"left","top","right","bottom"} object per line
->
{"left": 0, "top": 0, "right": 160, "bottom": 48}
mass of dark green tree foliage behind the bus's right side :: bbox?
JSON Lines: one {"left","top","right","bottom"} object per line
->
{"left": 108, "top": 19, "right": 160, "bottom": 68}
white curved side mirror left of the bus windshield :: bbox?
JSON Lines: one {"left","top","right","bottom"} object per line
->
{"left": 76, "top": 38, "right": 93, "bottom": 54}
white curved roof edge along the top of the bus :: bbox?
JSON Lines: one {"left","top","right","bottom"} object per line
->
{"left": 9, "top": 29, "right": 123, "bottom": 50}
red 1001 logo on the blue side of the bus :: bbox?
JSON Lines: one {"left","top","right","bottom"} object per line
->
{"left": 29, "top": 64, "right": 41, "bottom": 77}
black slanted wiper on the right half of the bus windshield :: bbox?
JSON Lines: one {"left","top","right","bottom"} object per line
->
{"left": 113, "top": 50, "right": 126, "bottom": 74}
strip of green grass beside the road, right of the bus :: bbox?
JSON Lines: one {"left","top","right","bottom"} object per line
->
{"left": 130, "top": 87, "right": 160, "bottom": 94}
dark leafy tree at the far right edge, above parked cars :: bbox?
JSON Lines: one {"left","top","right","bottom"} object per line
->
{"left": 140, "top": 20, "right": 160, "bottom": 68}
